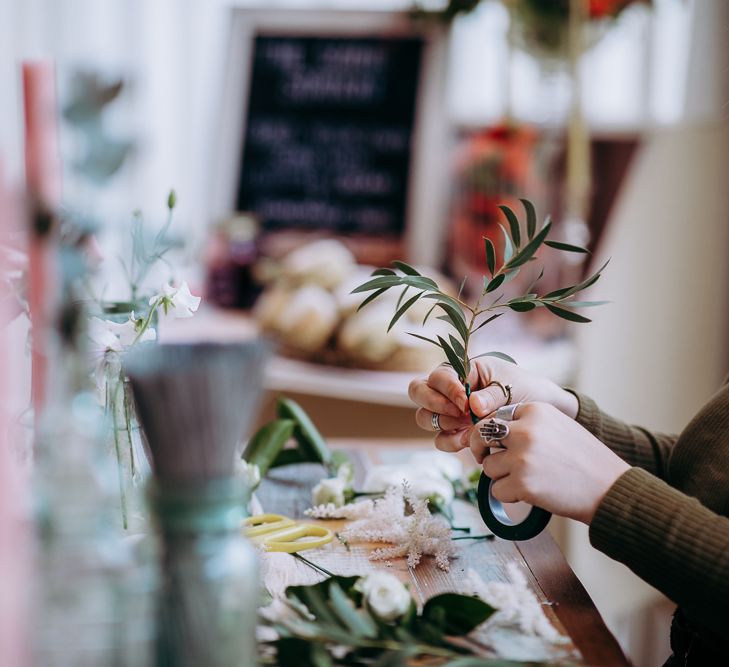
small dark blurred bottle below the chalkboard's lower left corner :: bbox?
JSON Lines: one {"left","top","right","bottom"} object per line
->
{"left": 206, "top": 214, "right": 261, "bottom": 309}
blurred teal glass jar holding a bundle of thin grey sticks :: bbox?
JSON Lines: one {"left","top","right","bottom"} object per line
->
{"left": 149, "top": 478, "right": 259, "bottom": 667}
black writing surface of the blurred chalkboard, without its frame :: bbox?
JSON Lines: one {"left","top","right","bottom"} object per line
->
{"left": 237, "top": 36, "right": 423, "bottom": 234}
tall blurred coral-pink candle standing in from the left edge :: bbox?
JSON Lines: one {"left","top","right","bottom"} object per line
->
{"left": 23, "top": 61, "right": 61, "bottom": 418}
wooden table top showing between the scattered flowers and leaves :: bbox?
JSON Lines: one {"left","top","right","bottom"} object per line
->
{"left": 258, "top": 441, "right": 630, "bottom": 667}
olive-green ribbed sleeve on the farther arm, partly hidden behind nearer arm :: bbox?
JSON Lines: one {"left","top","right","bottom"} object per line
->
{"left": 567, "top": 389, "right": 678, "bottom": 479}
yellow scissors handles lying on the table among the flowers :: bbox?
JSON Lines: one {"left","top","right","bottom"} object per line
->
{"left": 243, "top": 514, "right": 334, "bottom": 554}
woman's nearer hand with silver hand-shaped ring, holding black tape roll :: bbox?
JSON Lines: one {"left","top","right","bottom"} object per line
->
{"left": 469, "top": 403, "right": 630, "bottom": 525}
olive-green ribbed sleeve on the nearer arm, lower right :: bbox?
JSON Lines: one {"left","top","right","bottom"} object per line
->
{"left": 590, "top": 468, "right": 729, "bottom": 641}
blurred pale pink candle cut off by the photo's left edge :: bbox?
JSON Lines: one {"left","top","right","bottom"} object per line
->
{"left": 0, "top": 165, "right": 30, "bottom": 667}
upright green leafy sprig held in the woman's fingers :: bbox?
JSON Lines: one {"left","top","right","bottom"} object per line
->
{"left": 352, "top": 199, "right": 607, "bottom": 386}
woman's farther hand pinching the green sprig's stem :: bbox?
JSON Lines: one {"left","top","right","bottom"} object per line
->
{"left": 408, "top": 357, "right": 578, "bottom": 452}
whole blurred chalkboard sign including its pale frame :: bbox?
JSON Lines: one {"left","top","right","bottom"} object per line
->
{"left": 211, "top": 8, "right": 448, "bottom": 263}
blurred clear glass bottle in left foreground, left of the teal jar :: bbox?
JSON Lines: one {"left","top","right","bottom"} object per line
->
{"left": 33, "top": 330, "right": 157, "bottom": 667}
